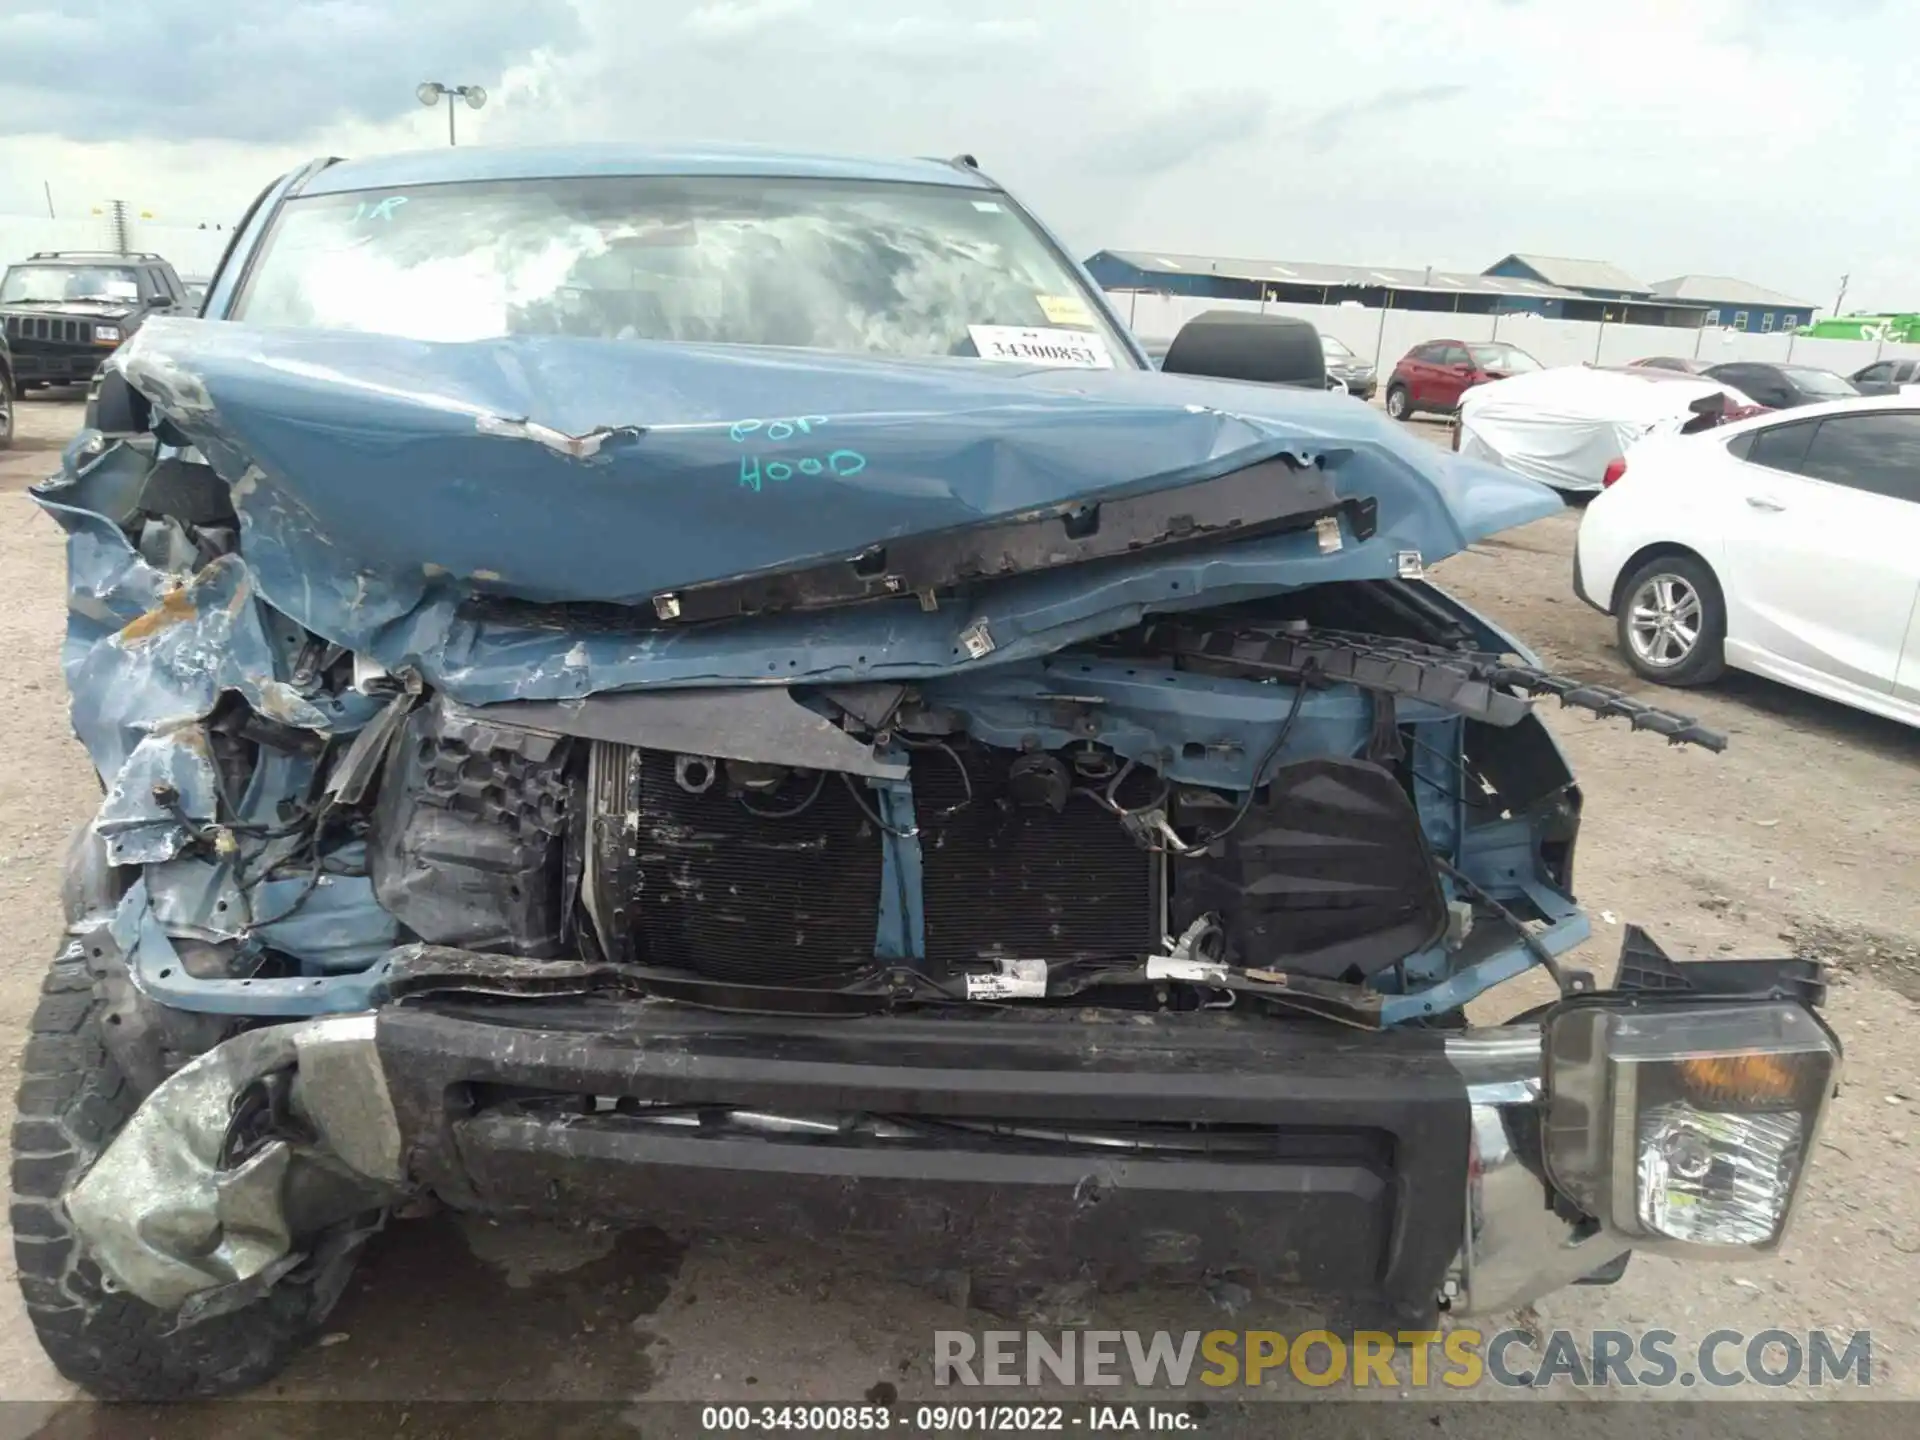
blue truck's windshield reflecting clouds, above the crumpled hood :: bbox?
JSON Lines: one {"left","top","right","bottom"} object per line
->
{"left": 238, "top": 179, "right": 1125, "bottom": 366}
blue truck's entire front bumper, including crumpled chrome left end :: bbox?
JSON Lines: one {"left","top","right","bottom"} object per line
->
{"left": 69, "top": 931, "right": 1837, "bottom": 1325}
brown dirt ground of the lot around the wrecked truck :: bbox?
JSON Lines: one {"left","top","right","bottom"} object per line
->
{"left": 0, "top": 399, "right": 1920, "bottom": 1434}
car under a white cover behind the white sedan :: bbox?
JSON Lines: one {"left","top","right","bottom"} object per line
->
{"left": 1455, "top": 365, "right": 1761, "bottom": 492}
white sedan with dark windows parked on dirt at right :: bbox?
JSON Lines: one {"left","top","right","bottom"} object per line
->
{"left": 1572, "top": 396, "right": 1920, "bottom": 726}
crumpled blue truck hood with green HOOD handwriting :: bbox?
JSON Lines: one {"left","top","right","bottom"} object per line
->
{"left": 56, "top": 317, "right": 1561, "bottom": 703}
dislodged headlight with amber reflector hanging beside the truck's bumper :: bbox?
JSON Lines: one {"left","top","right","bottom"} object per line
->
{"left": 1546, "top": 1002, "right": 1839, "bottom": 1250}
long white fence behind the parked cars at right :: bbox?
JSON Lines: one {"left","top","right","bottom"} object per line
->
{"left": 1108, "top": 290, "right": 1920, "bottom": 374}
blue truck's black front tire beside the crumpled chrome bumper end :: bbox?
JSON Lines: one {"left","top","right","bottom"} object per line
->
{"left": 10, "top": 945, "right": 351, "bottom": 1400}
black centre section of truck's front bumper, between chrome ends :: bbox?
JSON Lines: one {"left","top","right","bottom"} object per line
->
{"left": 378, "top": 998, "right": 1469, "bottom": 1323}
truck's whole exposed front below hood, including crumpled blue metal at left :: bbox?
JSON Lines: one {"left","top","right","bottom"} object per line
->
{"left": 48, "top": 491, "right": 1724, "bottom": 1029}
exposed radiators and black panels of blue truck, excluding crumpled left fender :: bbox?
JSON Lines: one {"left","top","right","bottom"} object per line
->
{"left": 349, "top": 582, "right": 1605, "bottom": 1023}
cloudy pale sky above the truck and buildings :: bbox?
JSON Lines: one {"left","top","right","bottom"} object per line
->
{"left": 0, "top": 0, "right": 1920, "bottom": 309}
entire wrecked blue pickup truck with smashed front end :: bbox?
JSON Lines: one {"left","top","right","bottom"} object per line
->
{"left": 12, "top": 148, "right": 1839, "bottom": 1398}
